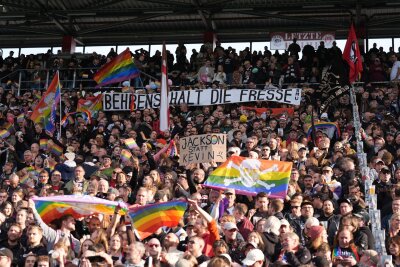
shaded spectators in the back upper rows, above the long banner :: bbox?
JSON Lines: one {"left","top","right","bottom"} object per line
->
{"left": 0, "top": 40, "right": 400, "bottom": 89}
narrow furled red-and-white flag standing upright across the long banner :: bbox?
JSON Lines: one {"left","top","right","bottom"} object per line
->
{"left": 160, "top": 43, "right": 169, "bottom": 132}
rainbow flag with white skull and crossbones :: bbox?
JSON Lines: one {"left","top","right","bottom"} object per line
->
{"left": 204, "top": 156, "right": 293, "bottom": 199}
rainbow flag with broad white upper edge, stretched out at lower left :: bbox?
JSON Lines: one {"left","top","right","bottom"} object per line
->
{"left": 33, "top": 195, "right": 128, "bottom": 223}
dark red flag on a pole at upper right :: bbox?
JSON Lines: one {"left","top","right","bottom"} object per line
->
{"left": 343, "top": 24, "right": 362, "bottom": 83}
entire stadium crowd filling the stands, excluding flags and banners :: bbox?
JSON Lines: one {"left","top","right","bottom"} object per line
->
{"left": 0, "top": 41, "right": 400, "bottom": 267}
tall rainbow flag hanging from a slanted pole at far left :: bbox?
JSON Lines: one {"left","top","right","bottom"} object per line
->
{"left": 31, "top": 72, "right": 61, "bottom": 130}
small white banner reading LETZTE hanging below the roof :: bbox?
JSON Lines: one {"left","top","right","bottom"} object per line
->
{"left": 270, "top": 32, "right": 335, "bottom": 50}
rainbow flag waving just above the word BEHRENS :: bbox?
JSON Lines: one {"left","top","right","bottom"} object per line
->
{"left": 93, "top": 48, "right": 140, "bottom": 87}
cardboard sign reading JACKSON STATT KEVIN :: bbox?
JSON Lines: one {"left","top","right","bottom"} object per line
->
{"left": 179, "top": 134, "right": 227, "bottom": 165}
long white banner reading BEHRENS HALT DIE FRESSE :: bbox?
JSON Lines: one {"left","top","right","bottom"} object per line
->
{"left": 103, "top": 88, "right": 301, "bottom": 111}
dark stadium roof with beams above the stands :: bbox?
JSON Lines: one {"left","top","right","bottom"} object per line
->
{"left": 0, "top": 0, "right": 400, "bottom": 47}
